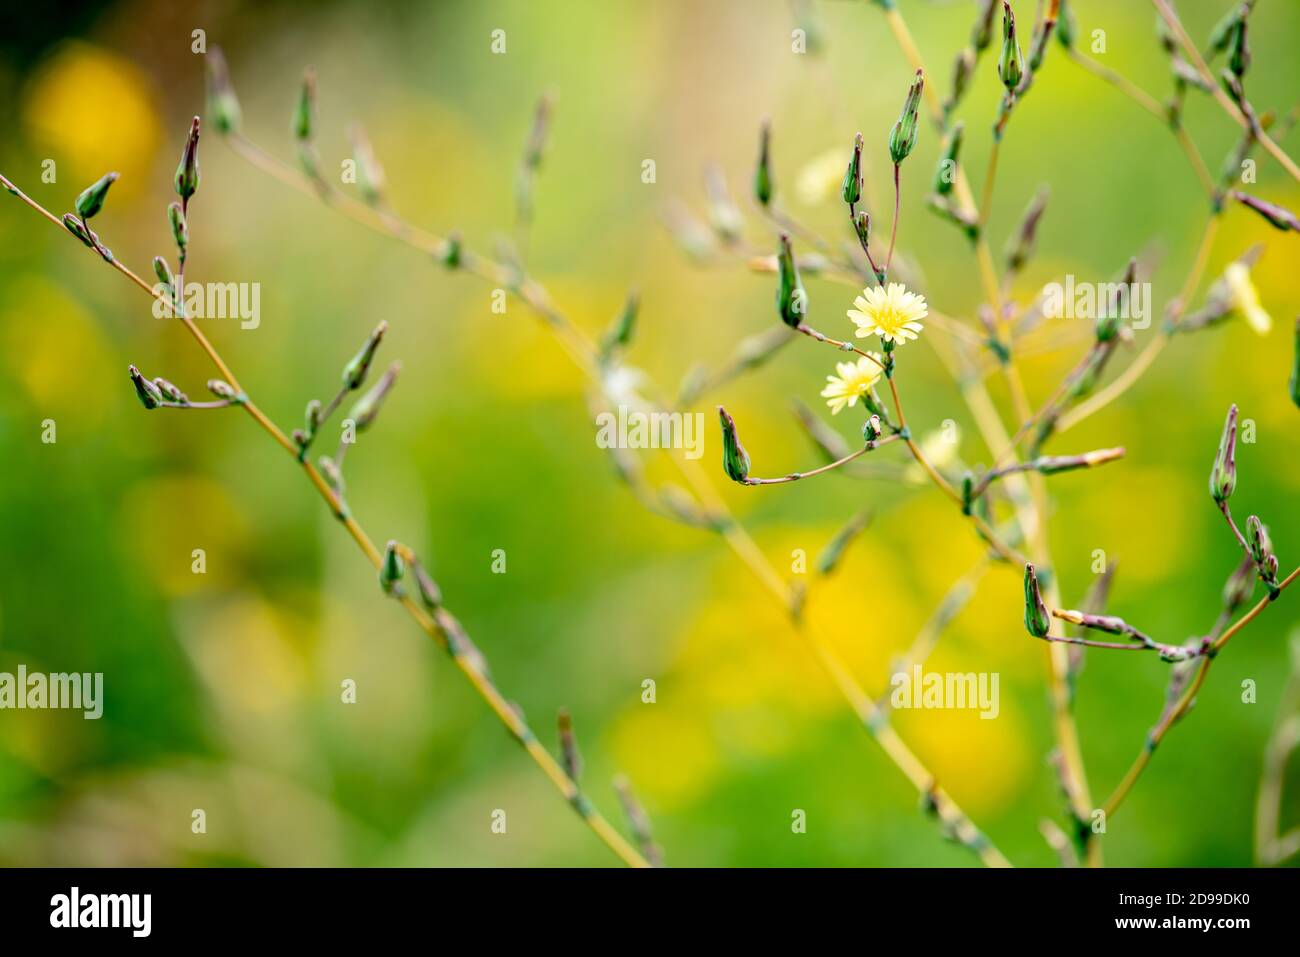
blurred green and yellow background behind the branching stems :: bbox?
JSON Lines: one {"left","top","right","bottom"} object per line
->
{"left": 0, "top": 0, "right": 1300, "bottom": 866}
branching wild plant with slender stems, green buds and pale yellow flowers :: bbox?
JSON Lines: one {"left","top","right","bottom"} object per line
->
{"left": 5, "top": 0, "right": 1300, "bottom": 866}
